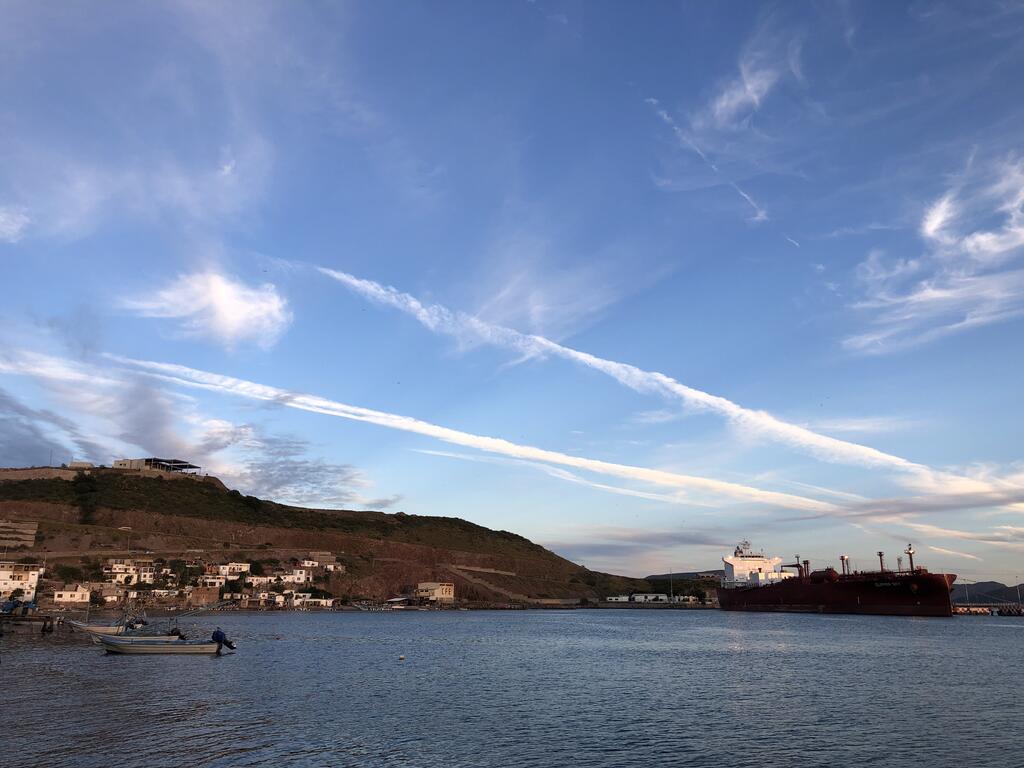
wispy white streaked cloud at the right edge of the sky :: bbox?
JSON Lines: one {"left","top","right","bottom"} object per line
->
{"left": 843, "top": 158, "right": 1024, "bottom": 354}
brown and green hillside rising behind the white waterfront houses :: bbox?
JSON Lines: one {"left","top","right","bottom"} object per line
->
{"left": 0, "top": 469, "right": 649, "bottom": 602}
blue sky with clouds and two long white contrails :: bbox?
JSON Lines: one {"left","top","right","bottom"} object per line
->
{"left": 0, "top": 0, "right": 1024, "bottom": 583}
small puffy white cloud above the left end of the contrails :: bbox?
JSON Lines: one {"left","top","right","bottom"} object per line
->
{"left": 122, "top": 272, "right": 292, "bottom": 348}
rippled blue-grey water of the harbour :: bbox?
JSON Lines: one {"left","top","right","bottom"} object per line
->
{"left": 0, "top": 610, "right": 1024, "bottom": 768}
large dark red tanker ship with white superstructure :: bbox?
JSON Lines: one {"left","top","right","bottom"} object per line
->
{"left": 718, "top": 542, "right": 956, "bottom": 616}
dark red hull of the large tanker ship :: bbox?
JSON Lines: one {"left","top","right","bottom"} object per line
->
{"left": 718, "top": 570, "right": 956, "bottom": 616}
